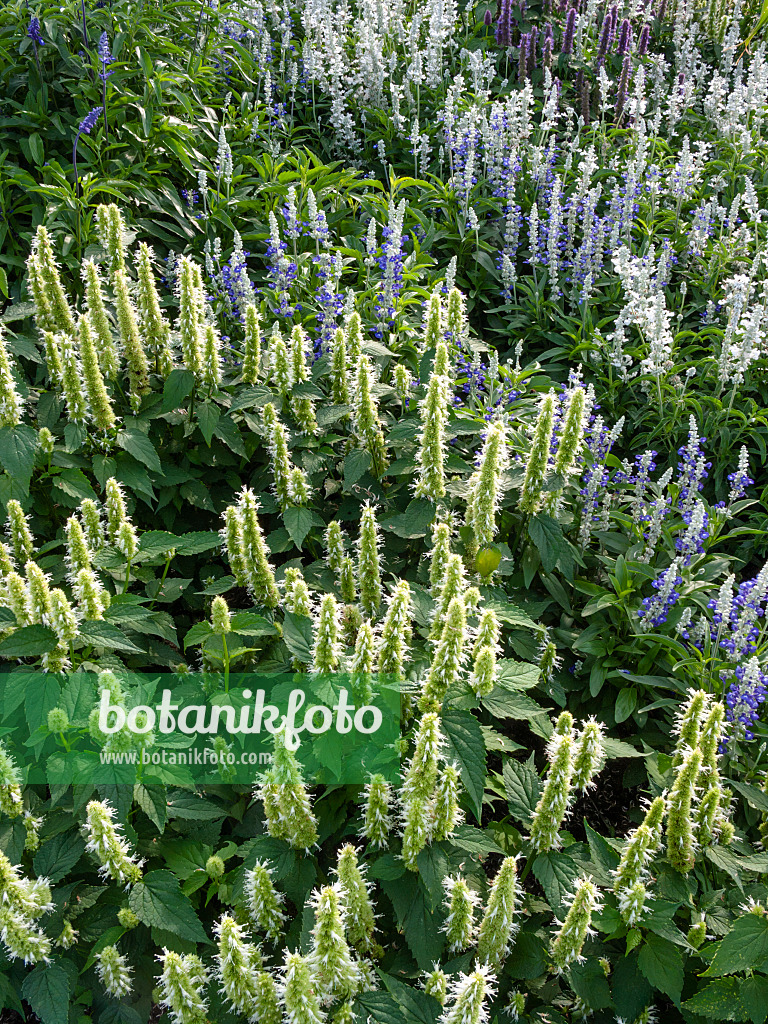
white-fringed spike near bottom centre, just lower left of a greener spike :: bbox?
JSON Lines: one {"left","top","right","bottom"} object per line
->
{"left": 307, "top": 882, "right": 358, "bottom": 1004}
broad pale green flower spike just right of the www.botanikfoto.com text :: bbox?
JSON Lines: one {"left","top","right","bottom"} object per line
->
{"left": 258, "top": 729, "right": 317, "bottom": 851}
